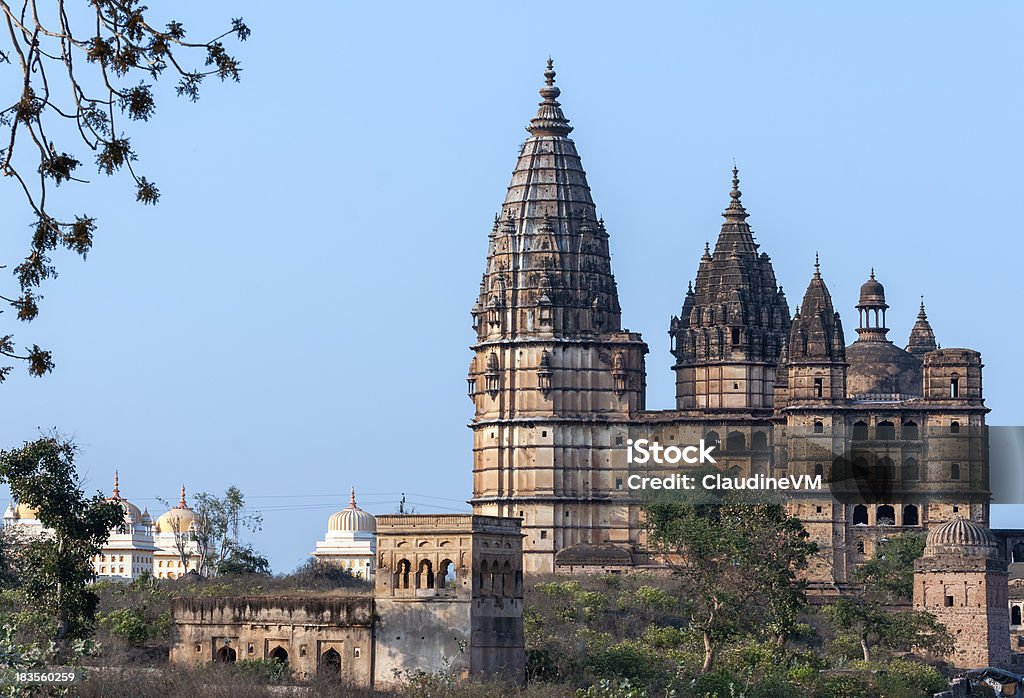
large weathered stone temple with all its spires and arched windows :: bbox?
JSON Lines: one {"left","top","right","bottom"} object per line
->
{"left": 469, "top": 59, "right": 989, "bottom": 591}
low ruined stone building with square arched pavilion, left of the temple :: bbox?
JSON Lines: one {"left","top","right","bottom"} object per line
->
{"left": 170, "top": 514, "right": 525, "bottom": 686}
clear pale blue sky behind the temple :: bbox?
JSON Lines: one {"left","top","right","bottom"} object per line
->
{"left": 0, "top": 2, "right": 1024, "bottom": 570}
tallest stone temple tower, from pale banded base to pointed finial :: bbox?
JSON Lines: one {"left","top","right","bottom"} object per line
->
{"left": 468, "top": 60, "right": 647, "bottom": 574}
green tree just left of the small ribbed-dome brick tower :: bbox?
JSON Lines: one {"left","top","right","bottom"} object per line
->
{"left": 824, "top": 533, "right": 953, "bottom": 661}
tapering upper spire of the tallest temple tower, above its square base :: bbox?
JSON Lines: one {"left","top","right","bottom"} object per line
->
{"left": 473, "top": 58, "right": 621, "bottom": 340}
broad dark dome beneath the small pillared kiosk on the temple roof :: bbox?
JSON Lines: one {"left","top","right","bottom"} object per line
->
{"left": 846, "top": 341, "right": 922, "bottom": 396}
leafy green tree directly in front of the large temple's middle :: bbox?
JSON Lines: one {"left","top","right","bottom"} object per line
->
{"left": 644, "top": 475, "right": 817, "bottom": 673}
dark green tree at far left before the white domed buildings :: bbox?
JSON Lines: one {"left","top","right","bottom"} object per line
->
{"left": 0, "top": 436, "right": 125, "bottom": 643}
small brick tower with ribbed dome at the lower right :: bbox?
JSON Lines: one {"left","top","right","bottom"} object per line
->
{"left": 913, "top": 517, "right": 1011, "bottom": 669}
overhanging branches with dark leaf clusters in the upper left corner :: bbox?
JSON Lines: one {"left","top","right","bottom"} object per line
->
{"left": 0, "top": 0, "right": 250, "bottom": 381}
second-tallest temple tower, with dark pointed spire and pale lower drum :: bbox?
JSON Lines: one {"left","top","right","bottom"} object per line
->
{"left": 669, "top": 168, "right": 790, "bottom": 410}
